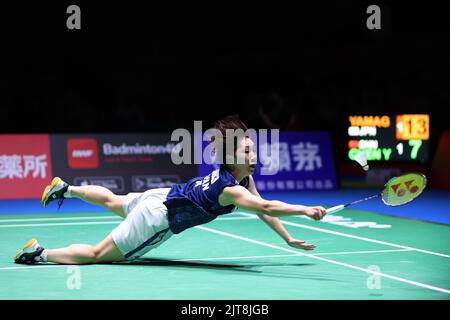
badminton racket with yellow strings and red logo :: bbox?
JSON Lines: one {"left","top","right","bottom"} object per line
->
{"left": 326, "top": 173, "right": 427, "bottom": 214}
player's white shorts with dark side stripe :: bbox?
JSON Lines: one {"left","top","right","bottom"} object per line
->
{"left": 111, "top": 188, "right": 173, "bottom": 260}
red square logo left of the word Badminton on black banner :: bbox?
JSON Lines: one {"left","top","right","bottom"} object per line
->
{"left": 67, "top": 139, "right": 99, "bottom": 169}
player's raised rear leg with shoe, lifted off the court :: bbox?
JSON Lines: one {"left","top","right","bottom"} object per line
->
{"left": 41, "top": 177, "right": 126, "bottom": 218}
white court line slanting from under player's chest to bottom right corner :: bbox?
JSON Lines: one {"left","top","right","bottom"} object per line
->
{"left": 194, "top": 226, "right": 450, "bottom": 294}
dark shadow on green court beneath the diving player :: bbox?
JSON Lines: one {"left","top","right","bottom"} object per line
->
{"left": 114, "top": 258, "right": 336, "bottom": 281}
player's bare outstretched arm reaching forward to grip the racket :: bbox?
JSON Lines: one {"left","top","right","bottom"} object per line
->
{"left": 219, "top": 186, "right": 326, "bottom": 220}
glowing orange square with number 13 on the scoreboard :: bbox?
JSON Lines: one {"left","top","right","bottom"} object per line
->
{"left": 395, "top": 114, "right": 430, "bottom": 140}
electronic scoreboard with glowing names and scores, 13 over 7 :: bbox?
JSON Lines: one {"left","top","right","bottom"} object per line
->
{"left": 347, "top": 114, "right": 430, "bottom": 163}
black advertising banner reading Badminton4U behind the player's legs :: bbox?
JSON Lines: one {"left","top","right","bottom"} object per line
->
{"left": 50, "top": 133, "right": 197, "bottom": 194}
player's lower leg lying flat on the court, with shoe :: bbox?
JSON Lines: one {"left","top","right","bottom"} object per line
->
{"left": 14, "top": 235, "right": 126, "bottom": 264}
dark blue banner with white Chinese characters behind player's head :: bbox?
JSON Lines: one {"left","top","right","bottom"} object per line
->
{"left": 197, "top": 132, "right": 338, "bottom": 191}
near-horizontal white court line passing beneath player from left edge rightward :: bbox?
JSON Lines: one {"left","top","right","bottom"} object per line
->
{"left": 0, "top": 249, "right": 409, "bottom": 270}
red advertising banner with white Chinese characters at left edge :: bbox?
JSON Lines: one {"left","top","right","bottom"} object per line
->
{"left": 0, "top": 134, "right": 52, "bottom": 199}
